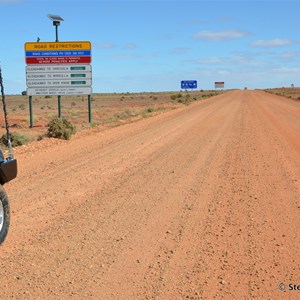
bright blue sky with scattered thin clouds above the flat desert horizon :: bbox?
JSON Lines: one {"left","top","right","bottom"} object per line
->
{"left": 0, "top": 0, "right": 300, "bottom": 94}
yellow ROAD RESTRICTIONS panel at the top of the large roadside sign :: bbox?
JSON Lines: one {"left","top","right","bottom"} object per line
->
{"left": 25, "top": 42, "right": 92, "bottom": 51}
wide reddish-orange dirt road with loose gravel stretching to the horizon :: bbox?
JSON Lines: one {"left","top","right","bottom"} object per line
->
{"left": 0, "top": 91, "right": 300, "bottom": 300}
